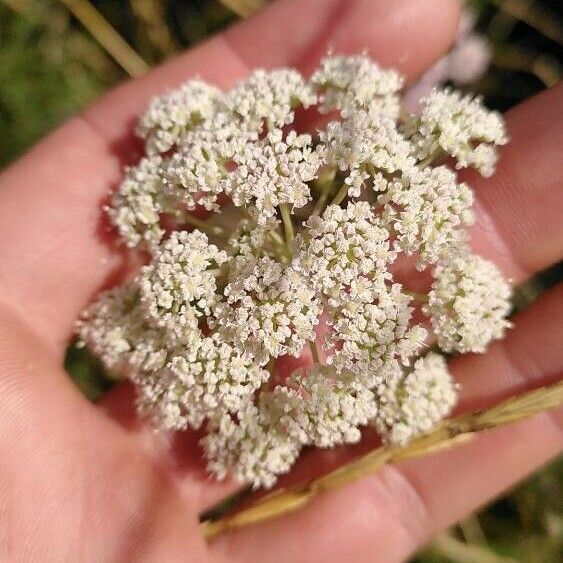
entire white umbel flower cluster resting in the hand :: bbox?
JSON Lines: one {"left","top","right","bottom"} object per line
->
{"left": 79, "top": 55, "right": 510, "bottom": 487}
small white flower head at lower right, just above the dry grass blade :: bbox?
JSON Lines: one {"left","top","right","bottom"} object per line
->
{"left": 373, "top": 352, "right": 457, "bottom": 445}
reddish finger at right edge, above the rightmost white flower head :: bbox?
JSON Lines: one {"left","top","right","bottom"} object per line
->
{"left": 465, "top": 84, "right": 563, "bottom": 283}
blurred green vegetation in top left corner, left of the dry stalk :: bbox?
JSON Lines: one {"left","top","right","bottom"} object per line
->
{"left": 0, "top": 2, "right": 109, "bottom": 164}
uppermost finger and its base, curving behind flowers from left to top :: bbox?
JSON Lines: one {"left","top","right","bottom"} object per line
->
{"left": 0, "top": 0, "right": 459, "bottom": 350}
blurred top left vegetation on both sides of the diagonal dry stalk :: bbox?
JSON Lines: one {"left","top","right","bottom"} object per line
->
{"left": 0, "top": 0, "right": 235, "bottom": 167}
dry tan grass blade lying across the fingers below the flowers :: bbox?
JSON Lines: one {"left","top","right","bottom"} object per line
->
{"left": 201, "top": 381, "right": 563, "bottom": 539}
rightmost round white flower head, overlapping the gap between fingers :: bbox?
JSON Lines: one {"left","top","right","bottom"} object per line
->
{"left": 424, "top": 254, "right": 511, "bottom": 353}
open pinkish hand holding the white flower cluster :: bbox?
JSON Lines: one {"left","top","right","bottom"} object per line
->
{"left": 0, "top": 0, "right": 563, "bottom": 562}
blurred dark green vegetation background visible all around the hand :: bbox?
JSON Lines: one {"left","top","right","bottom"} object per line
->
{"left": 0, "top": 0, "right": 563, "bottom": 563}
